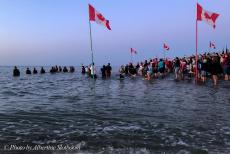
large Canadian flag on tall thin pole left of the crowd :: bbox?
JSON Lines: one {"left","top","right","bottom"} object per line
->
{"left": 89, "top": 4, "right": 111, "bottom": 30}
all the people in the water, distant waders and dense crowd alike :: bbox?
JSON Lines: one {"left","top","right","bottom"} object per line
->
{"left": 13, "top": 49, "right": 230, "bottom": 85}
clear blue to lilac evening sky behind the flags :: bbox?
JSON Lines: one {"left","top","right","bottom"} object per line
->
{"left": 0, "top": 0, "right": 230, "bottom": 66}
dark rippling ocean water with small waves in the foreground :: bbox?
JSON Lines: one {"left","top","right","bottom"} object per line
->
{"left": 0, "top": 67, "right": 230, "bottom": 154}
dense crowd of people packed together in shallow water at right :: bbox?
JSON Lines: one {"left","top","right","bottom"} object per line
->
{"left": 119, "top": 49, "right": 230, "bottom": 85}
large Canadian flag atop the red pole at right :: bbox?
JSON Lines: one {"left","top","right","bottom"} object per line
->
{"left": 197, "top": 3, "right": 219, "bottom": 29}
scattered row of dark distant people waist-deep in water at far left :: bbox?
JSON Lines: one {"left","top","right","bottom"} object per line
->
{"left": 13, "top": 66, "right": 75, "bottom": 77}
